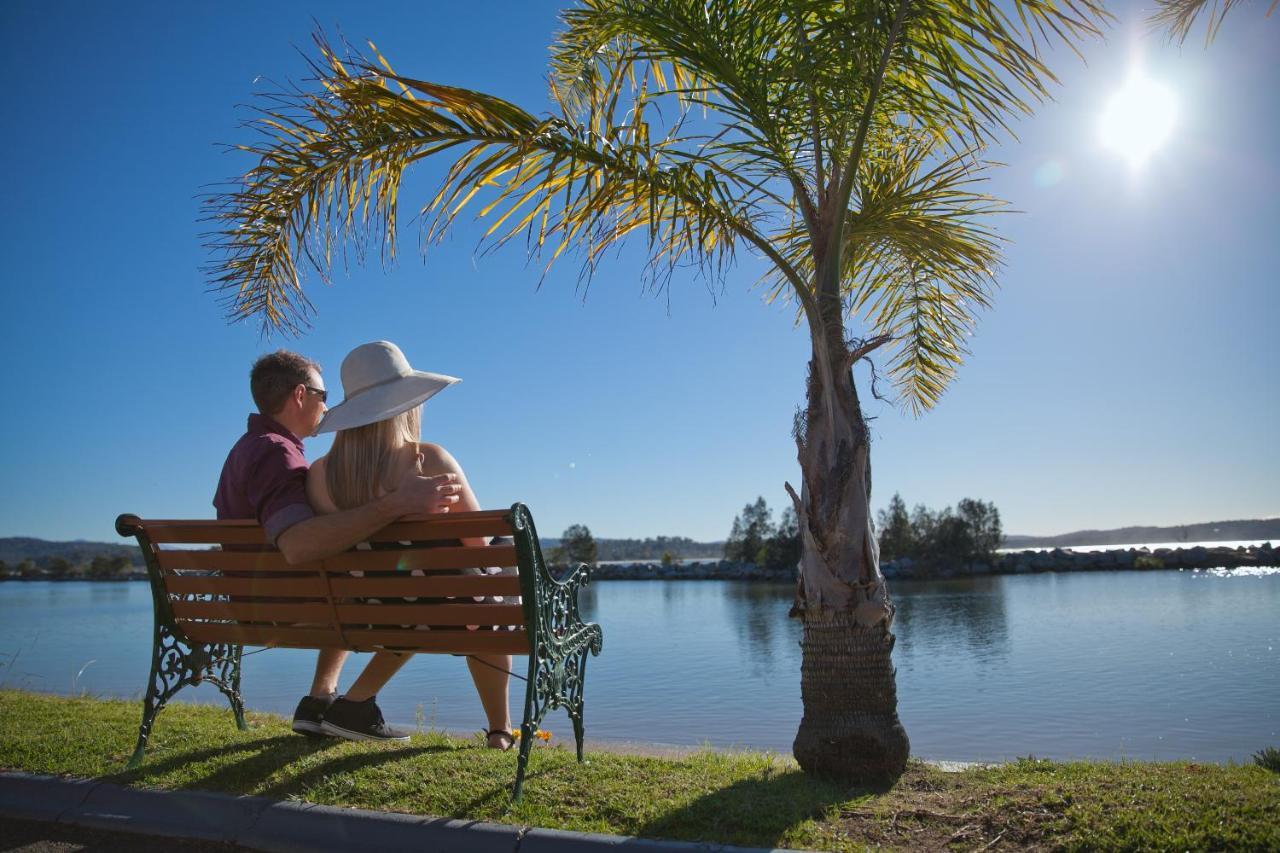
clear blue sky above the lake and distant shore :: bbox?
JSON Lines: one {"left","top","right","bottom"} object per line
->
{"left": 0, "top": 0, "right": 1280, "bottom": 540}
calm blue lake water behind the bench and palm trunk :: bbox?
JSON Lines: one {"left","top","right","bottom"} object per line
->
{"left": 0, "top": 569, "right": 1280, "bottom": 762}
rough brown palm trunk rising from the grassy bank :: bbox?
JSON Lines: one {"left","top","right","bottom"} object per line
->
{"left": 787, "top": 286, "right": 910, "bottom": 783}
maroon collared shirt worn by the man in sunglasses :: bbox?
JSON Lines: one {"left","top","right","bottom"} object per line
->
{"left": 214, "top": 414, "right": 315, "bottom": 542}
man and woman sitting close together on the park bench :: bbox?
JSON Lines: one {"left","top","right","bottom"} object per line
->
{"left": 214, "top": 341, "right": 513, "bottom": 749}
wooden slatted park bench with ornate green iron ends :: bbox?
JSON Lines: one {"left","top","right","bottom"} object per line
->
{"left": 115, "top": 503, "right": 603, "bottom": 799}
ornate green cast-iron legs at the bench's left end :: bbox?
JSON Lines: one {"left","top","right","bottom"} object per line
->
{"left": 128, "top": 624, "right": 247, "bottom": 770}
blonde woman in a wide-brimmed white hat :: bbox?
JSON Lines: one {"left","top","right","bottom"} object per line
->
{"left": 307, "top": 341, "right": 513, "bottom": 749}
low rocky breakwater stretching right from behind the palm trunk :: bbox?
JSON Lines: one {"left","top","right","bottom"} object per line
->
{"left": 881, "top": 542, "right": 1280, "bottom": 578}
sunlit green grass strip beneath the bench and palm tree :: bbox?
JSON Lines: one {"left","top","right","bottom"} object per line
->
{"left": 0, "top": 690, "right": 1280, "bottom": 850}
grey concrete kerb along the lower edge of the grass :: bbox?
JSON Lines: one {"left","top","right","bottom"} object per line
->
{"left": 0, "top": 772, "right": 786, "bottom": 853}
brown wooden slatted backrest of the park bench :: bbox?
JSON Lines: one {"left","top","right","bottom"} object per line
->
{"left": 116, "top": 505, "right": 541, "bottom": 654}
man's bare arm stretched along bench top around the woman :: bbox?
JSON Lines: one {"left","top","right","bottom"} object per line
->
{"left": 275, "top": 473, "right": 461, "bottom": 564}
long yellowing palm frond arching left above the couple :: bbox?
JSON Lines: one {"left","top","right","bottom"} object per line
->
{"left": 206, "top": 40, "right": 788, "bottom": 333}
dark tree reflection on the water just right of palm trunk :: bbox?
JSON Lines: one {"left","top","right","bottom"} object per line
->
{"left": 890, "top": 576, "right": 1009, "bottom": 661}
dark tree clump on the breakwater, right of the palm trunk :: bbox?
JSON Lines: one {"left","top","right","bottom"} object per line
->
{"left": 877, "top": 493, "right": 1004, "bottom": 565}
